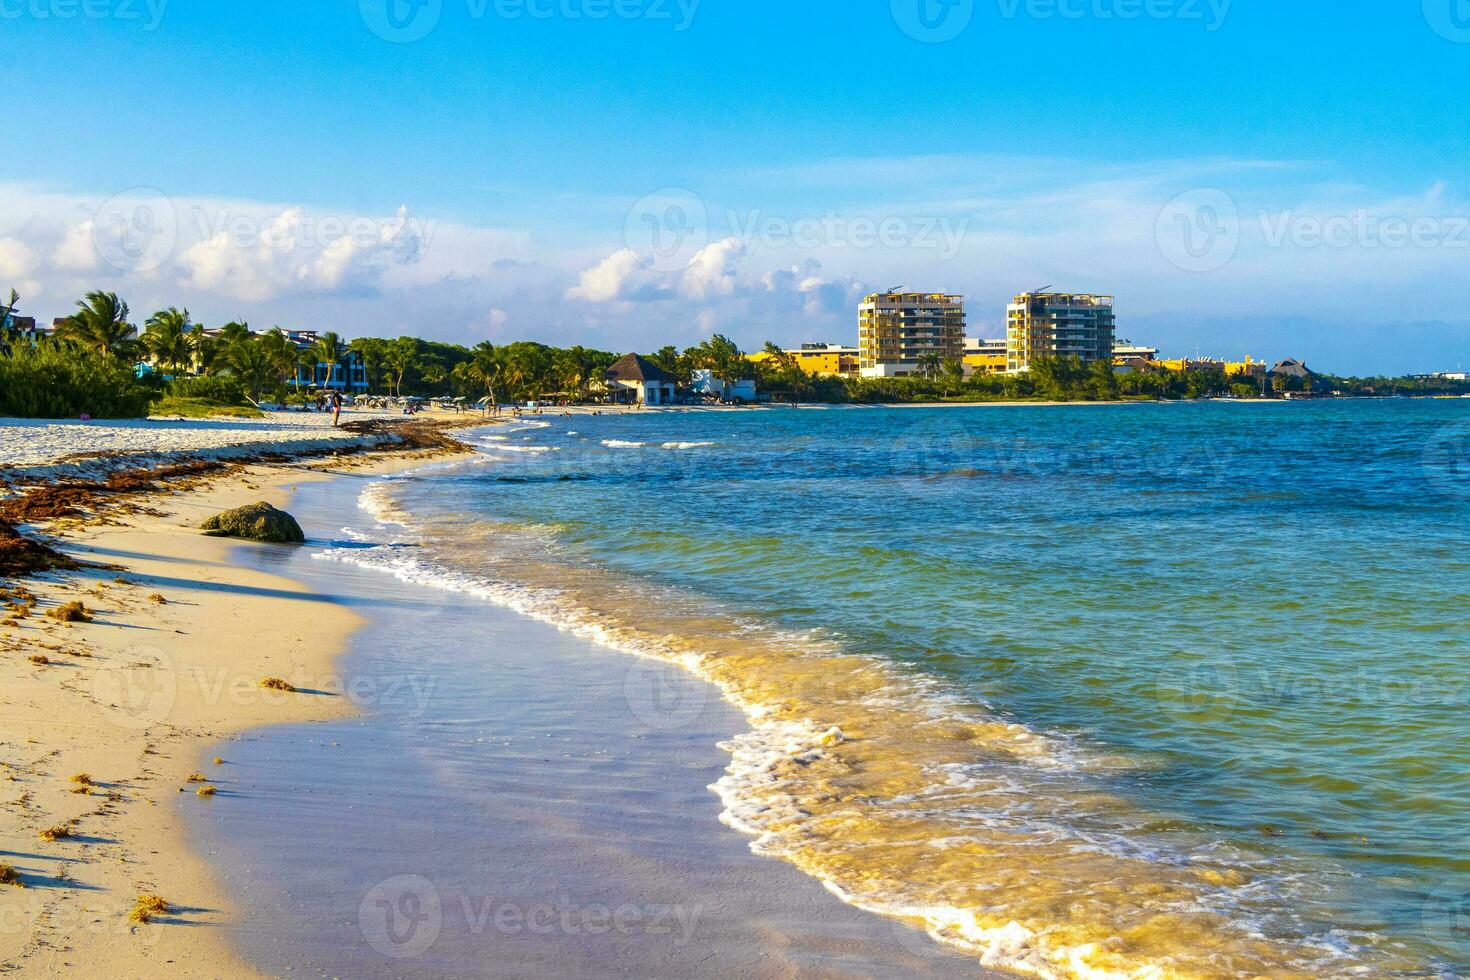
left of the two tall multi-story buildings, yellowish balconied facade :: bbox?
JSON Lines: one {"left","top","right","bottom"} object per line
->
{"left": 857, "top": 292, "right": 964, "bottom": 378}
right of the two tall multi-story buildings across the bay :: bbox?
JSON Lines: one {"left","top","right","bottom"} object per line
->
{"left": 1005, "top": 292, "right": 1114, "bottom": 373}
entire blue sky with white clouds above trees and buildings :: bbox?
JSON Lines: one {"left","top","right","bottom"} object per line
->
{"left": 0, "top": 0, "right": 1470, "bottom": 375}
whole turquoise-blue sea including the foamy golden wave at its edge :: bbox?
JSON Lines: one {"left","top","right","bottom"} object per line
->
{"left": 354, "top": 400, "right": 1470, "bottom": 976}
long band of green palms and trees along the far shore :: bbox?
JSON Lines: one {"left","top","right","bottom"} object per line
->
{"left": 0, "top": 291, "right": 1470, "bottom": 419}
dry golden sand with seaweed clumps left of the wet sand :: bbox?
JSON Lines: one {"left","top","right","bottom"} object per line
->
{"left": 0, "top": 450, "right": 470, "bottom": 977}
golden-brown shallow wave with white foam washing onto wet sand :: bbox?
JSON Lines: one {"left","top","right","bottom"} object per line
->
{"left": 319, "top": 480, "right": 1401, "bottom": 980}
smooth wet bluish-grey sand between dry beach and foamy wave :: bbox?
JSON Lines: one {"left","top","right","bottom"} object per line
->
{"left": 188, "top": 478, "right": 985, "bottom": 977}
